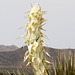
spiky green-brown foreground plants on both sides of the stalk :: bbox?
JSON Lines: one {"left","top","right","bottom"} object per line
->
{"left": 0, "top": 51, "right": 75, "bottom": 75}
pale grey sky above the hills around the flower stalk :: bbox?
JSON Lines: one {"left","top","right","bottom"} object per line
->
{"left": 0, "top": 0, "right": 75, "bottom": 48}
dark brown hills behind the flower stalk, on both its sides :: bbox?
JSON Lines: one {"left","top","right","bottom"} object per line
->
{"left": 0, "top": 46, "right": 75, "bottom": 74}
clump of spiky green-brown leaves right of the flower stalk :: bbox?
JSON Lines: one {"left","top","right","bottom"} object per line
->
{"left": 50, "top": 52, "right": 75, "bottom": 75}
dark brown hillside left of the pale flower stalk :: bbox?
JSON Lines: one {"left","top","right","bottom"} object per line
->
{"left": 0, "top": 47, "right": 27, "bottom": 66}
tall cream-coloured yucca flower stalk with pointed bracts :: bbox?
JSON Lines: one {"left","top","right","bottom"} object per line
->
{"left": 19, "top": 4, "right": 50, "bottom": 75}
